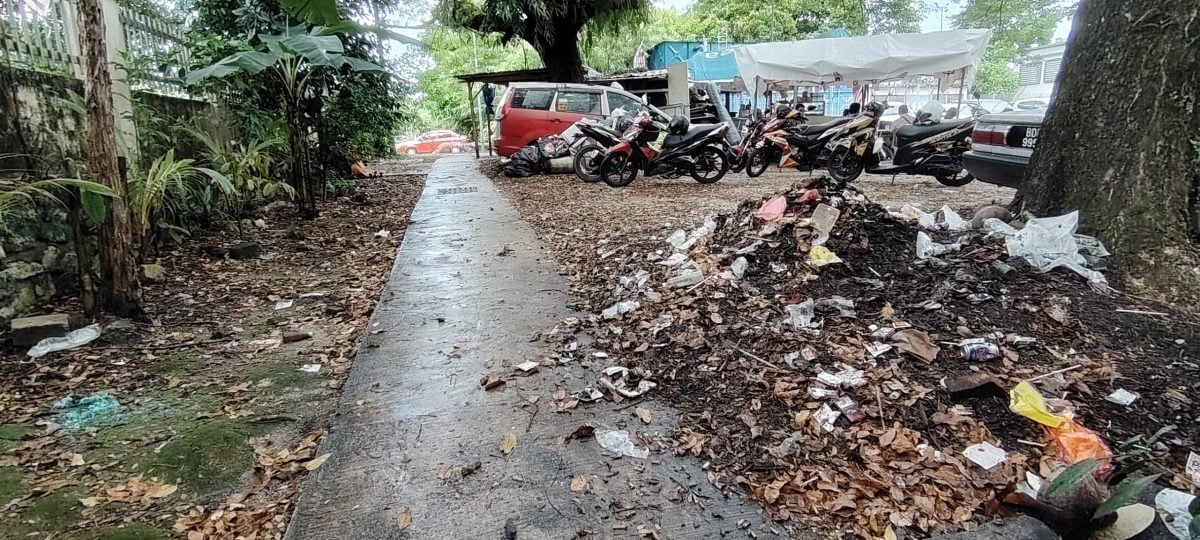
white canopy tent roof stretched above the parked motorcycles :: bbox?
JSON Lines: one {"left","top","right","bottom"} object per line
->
{"left": 733, "top": 29, "right": 991, "bottom": 86}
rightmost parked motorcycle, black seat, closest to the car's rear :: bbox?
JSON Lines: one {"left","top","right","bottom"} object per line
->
{"left": 828, "top": 102, "right": 976, "bottom": 187}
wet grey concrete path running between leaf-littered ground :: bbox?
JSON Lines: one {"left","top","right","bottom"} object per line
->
{"left": 287, "top": 157, "right": 778, "bottom": 540}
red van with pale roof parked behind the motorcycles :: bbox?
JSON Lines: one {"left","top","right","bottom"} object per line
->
{"left": 492, "top": 83, "right": 647, "bottom": 157}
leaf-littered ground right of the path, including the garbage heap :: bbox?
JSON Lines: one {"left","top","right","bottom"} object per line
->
{"left": 497, "top": 168, "right": 1200, "bottom": 538}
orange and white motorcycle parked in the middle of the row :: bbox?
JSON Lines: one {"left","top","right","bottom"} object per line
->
{"left": 746, "top": 106, "right": 851, "bottom": 178}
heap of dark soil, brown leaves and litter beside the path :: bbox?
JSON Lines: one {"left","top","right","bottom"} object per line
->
{"left": 568, "top": 179, "right": 1190, "bottom": 538}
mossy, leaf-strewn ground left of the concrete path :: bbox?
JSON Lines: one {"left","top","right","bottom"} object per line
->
{"left": 0, "top": 162, "right": 427, "bottom": 540}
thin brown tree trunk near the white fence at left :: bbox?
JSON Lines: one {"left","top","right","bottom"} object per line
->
{"left": 79, "top": 0, "right": 144, "bottom": 317}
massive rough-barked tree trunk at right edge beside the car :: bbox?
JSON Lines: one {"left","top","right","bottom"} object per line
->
{"left": 1020, "top": 0, "right": 1200, "bottom": 298}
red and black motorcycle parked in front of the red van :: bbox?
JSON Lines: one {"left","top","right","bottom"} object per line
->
{"left": 600, "top": 112, "right": 730, "bottom": 187}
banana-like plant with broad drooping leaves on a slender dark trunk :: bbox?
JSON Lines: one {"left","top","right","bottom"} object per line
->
{"left": 186, "top": 25, "right": 384, "bottom": 214}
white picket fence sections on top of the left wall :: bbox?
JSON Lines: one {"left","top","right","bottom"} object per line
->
{"left": 0, "top": 0, "right": 191, "bottom": 97}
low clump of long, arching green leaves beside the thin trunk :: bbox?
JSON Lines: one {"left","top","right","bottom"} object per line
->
{"left": 128, "top": 150, "right": 235, "bottom": 241}
